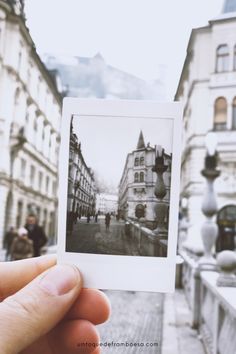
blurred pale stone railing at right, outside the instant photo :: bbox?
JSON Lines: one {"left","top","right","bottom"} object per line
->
{"left": 181, "top": 250, "right": 236, "bottom": 354}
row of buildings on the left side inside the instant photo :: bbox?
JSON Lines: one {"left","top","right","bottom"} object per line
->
{"left": 67, "top": 123, "right": 96, "bottom": 217}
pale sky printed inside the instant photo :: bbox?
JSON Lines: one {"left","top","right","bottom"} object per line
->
{"left": 73, "top": 115, "right": 173, "bottom": 188}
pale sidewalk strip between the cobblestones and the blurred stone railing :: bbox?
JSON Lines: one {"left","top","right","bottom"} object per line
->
{"left": 162, "top": 289, "right": 206, "bottom": 354}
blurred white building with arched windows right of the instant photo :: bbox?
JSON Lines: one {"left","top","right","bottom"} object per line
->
{"left": 175, "top": 0, "right": 236, "bottom": 247}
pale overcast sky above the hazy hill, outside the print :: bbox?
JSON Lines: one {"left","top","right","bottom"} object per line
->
{"left": 26, "top": 0, "right": 223, "bottom": 99}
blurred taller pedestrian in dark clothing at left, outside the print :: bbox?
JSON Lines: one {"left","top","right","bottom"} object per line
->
{"left": 25, "top": 214, "right": 48, "bottom": 257}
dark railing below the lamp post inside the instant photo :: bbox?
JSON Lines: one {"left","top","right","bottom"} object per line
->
{"left": 125, "top": 219, "right": 168, "bottom": 257}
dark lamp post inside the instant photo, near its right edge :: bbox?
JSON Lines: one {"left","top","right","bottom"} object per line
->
{"left": 152, "top": 147, "right": 168, "bottom": 238}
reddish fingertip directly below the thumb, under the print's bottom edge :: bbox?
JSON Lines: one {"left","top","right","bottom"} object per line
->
{"left": 66, "top": 289, "right": 111, "bottom": 325}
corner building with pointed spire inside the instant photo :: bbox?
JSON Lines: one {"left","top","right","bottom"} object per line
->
{"left": 118, "top": 132, "right": 171, "bottom": 228}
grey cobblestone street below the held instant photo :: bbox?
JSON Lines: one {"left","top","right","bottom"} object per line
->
{"left": 98, "top": 291, "right": 163, "bottom": 354}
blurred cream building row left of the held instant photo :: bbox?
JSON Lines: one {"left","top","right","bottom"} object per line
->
{"left": 0, "top": 1, "right": 61, "bottom": 241}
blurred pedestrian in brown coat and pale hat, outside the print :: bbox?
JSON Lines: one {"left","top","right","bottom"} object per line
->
{"left": 11, "top": 227, "right": 34, "bottom": 261}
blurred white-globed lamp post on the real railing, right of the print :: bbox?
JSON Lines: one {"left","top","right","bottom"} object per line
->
{"left": 199, "top": 132, "right": 220, "bottom": 266}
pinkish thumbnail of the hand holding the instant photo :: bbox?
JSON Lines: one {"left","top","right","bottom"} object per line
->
{"left": 40, "top": 265, "right": 81, "bottom": 296}
